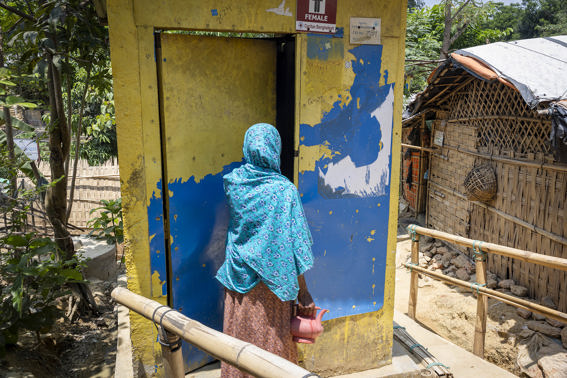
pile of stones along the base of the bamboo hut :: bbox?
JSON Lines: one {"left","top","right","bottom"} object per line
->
{"left": 408, "top": 236, "right": 567, "bottom": 377}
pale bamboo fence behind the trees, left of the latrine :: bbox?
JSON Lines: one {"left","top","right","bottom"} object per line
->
{"left": 38, "top": 160, "right": 120, "bottom": 228}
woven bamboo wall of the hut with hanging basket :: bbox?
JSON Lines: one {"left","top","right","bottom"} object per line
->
{"left": 428, "top": 80, "right": 567, "bottom": 311}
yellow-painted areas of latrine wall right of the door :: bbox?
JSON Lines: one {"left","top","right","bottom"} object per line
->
{"left": 296, "top": 1, "right": 407, "bottom": 376}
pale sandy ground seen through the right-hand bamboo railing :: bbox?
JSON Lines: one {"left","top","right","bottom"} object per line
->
{"left": 394, "top": 240, "right": 526, "bottom": 374}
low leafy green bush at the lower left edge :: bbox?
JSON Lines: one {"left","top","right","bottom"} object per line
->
{"left": 0, "top": 233, "right": 84, "bottom": 355}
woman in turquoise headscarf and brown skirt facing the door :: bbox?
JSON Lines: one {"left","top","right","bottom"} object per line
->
{"left": 216, "top": 123, "right": 315, "bottom": 377}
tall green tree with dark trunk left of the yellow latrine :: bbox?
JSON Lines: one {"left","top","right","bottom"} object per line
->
{"left": 0, "top": 0, "right": 109, "bottom": 312}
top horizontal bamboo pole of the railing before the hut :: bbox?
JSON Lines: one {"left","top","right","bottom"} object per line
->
{"left": 408, "top": 225, "right": 567, "bottom": 271}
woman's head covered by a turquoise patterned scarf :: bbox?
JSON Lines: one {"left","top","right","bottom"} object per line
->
{"left": 242, "top": 123, "right": 282, "bottom": 172}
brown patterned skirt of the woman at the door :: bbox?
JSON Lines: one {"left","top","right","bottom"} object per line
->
{"left": 221, "top": 282, "right": 297, "bottom": 378}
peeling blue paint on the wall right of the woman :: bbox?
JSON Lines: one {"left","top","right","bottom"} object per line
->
{"left": 299, "top": 42, "right": 394, "bottom": 318}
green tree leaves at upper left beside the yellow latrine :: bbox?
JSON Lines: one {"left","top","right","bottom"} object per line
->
{"left": 0, "top": 0, "right": 117, "bottom": 165}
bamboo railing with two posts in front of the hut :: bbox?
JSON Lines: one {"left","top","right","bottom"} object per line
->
{"left": 404, "top": 224, "right": 567, "bottom": 358}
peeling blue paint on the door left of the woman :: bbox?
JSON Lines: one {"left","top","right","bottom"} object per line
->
{"left": 148, "top": 162, "right": 242, "bottom": 368}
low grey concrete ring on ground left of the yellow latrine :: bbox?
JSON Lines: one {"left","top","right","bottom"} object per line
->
{"left": 73, "top": 236, "right": 118, "bottom": 281}
